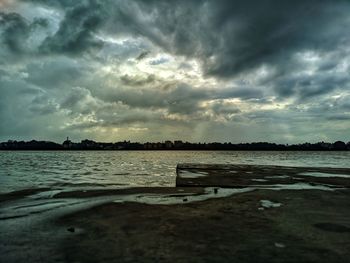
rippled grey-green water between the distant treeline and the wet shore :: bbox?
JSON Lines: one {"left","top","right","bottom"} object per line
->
{"left": 0, "top": 151, "right": 350, "bottom": 193}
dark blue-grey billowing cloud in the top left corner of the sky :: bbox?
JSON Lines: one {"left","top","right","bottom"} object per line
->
{"left": 0, "top": 0, "right": 108, "bottom": 55}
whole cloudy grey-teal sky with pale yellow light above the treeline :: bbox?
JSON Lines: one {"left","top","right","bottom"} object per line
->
{"left": 0, "top": 0, "right": 350, "bottom": 143}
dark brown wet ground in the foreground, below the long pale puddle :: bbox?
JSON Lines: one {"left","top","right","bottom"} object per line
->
{"left": 58, "top": 190, "right": 350, "bottom": 262}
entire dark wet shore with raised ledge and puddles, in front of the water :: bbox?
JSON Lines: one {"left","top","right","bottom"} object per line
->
{"left": 0, "top": 166, "right": 350, "bottom": 262}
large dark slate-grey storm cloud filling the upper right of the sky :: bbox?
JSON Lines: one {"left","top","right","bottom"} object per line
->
{"left": 121, "top": 0, "right": 350, "bottom": 77}
